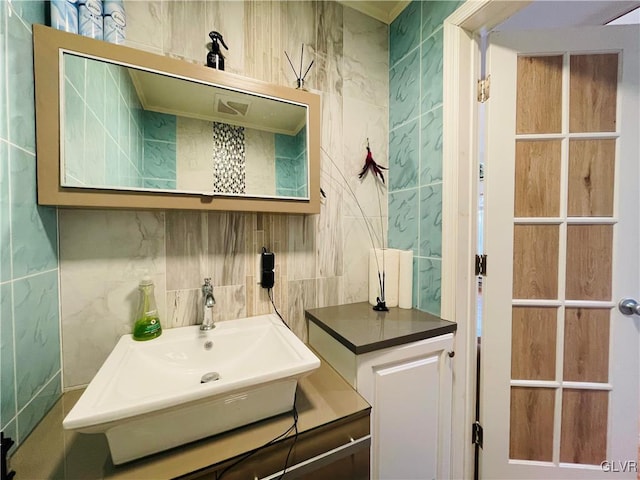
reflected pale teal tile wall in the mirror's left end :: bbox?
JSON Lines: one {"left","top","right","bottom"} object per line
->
{"left": 64, "top": 55, "right": 144, "bottom": 187}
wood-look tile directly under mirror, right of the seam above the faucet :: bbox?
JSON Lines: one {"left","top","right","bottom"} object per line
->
{"left": 208, "top": 212, "right": 246, "bottom": 287}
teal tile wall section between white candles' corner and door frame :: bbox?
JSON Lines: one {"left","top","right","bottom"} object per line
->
{"left": 389, "top": 0, "right": 462, "bottom": 315}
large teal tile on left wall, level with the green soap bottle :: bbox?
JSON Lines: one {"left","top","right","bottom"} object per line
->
{"left": 13, "top": 270, "right": 60, "bottom": 410}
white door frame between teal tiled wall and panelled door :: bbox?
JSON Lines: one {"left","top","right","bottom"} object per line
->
{"left": 440, "top": 0, "right": 531, "bottom": 479}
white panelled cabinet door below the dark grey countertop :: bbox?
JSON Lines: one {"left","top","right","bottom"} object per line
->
{"left": 358, "top": 335, "right": 453, "bottom": 480}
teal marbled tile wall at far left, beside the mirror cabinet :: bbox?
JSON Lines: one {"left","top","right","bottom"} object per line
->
{"left": 0, "top": 0, "right": 61, "bottom": 448}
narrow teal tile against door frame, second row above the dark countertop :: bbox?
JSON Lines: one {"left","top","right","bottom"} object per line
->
{"left": 420, "top": 183, "right": 442, "bottom": 258}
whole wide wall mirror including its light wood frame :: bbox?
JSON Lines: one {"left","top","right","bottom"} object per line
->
{"left": 33, "top": 25, "right": 320, "bottom": 213}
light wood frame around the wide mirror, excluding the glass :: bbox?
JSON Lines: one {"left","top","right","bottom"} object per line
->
{"left": 33, "top": 25, "right": 320, "bottom": 214}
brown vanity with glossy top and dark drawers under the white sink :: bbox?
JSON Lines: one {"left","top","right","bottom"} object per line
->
{"left": 9, "top": 361, "right": 371, "bottom": 480}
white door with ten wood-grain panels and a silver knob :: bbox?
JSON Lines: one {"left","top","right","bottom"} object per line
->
{"left": 480, "top": 26, "right": 640, "bottom": 479}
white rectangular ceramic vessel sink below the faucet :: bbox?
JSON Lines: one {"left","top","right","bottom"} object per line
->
{"left": 62, "top": 314, "right": 320, "bottom": 465}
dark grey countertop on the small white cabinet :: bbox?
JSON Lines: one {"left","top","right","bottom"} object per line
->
{"left": 305, "top": 302, "right": 457, "bottom": 354}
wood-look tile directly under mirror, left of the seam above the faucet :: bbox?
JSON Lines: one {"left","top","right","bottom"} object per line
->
{"left": 165, "top": 210, "right": 207, "bottom": 290}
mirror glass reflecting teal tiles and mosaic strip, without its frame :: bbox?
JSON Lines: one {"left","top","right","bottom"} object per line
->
{"left": 60, "top": 52, "right": 309, "bottom": 199}
